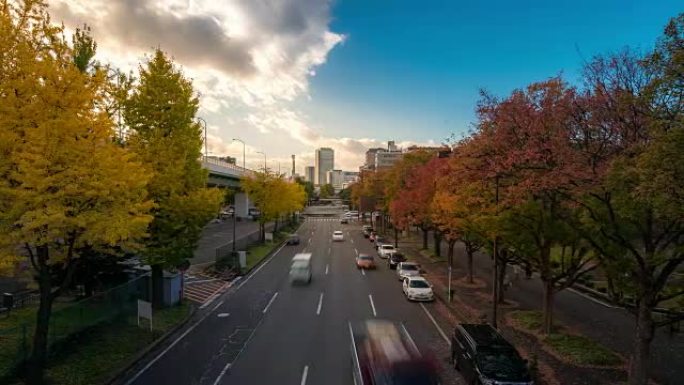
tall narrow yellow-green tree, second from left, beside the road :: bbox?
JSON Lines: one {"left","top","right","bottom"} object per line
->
{"left": 123, "top": 49, "right": 223, "bottom": 307}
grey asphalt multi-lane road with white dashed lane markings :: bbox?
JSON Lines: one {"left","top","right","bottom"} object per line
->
{"left": 122, "top": 219, "right": 462, "bottom": 385}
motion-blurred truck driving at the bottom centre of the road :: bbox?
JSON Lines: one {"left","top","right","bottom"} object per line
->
{"left": 349, "top": 320, "right": 439, "bottom": 385}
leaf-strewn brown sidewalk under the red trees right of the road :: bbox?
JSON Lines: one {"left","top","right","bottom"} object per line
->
{"left": 390, "top": 230, "right": 684, "bottom": 384}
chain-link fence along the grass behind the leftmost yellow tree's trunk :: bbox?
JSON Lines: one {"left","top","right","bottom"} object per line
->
{"left": 0, "top": 277, "right": 148, "bottom": 383}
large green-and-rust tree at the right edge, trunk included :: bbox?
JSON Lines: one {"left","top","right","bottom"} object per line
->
{"left": 576, "top": 22, "right": 684, "bottom": 385}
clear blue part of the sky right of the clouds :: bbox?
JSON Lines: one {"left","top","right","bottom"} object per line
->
{"left": 301, "top": 0, "right": 684, "bottom": 141}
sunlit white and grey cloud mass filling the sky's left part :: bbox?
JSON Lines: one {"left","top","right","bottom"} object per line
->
{"left": 49, "top": 0, "right": 432, "bottom": 173}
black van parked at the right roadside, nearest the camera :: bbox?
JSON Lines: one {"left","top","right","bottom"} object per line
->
{"left": 451, "top": 324, "right": 533, "bottom": 385}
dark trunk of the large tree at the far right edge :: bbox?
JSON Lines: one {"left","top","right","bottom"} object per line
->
{"left": 629, "top": 299, "right": 654, "bottom": 385}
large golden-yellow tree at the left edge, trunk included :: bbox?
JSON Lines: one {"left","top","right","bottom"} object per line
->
{"left": 0, "top": 0, "right": 152, "bottom": 384}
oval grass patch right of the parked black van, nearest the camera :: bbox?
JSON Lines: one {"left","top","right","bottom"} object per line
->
{"left": 544, "top": 334, "right": 622, "bottom": 366}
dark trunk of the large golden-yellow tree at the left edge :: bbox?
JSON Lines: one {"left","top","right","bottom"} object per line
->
{"left": 26, "top": 246, "right": 54, "bottom": 385}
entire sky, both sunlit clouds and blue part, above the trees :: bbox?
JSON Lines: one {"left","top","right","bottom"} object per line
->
{"left": 48, "top": 0, "right": 682, "bottom": 173}
